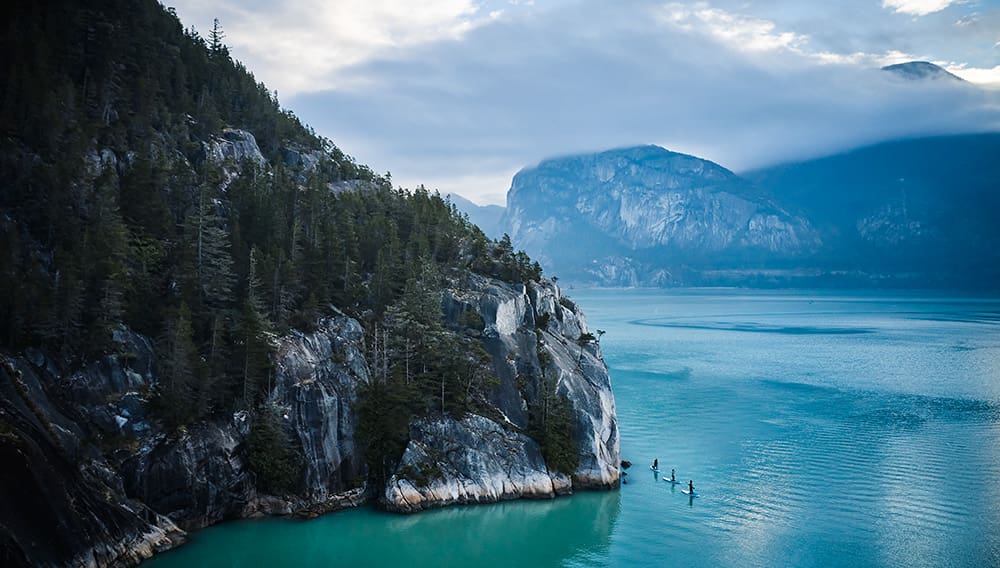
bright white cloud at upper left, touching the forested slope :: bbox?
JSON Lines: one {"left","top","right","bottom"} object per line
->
{"left": 171, "top": 0, "right": 501, "bottom": 96}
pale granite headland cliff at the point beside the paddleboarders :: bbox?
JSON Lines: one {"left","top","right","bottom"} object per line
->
{"left": 383, "top": 277, "right": 620, "bottom": 512}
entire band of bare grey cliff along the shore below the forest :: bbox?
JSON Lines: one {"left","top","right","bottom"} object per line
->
{"left": 0, "top": 275, "right": 619, "bottom": 566}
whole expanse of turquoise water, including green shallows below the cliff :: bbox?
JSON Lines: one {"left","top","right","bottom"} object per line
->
{"left": 146, "top": 290, "right": 1000, "bottom": 567}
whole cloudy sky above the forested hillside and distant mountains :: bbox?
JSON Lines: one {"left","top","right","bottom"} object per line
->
{"left": 170, "top": 0, "right": 1000, "bottom": 204}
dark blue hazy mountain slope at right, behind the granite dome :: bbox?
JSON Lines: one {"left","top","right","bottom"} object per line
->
{"left": 744, "top": 134, "right": 1000, "bottom": 288}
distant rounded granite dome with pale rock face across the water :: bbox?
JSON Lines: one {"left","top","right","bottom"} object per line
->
{"left": 503, "top": 146, "right": 821, "bottom": 285}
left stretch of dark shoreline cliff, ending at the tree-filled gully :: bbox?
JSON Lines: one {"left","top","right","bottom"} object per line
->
{"left": 0, "top": 317, "right": 368, "bottom": 566}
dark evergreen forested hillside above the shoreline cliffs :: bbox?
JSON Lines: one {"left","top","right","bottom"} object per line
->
{"left": 0, "top": 0, "right": 541, "bottom": 474}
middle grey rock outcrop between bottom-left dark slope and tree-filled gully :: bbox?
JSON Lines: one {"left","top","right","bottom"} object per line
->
{"left": 125, "top": 317, "right": 368, "bottom": 529}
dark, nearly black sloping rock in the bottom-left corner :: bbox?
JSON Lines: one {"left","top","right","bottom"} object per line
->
{"left": 0, "top": 353, "right": 185, "bottom": 566}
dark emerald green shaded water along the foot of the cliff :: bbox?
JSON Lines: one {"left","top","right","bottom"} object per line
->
{"left": 143, "top": 491, "right": 621, "bottom": 568}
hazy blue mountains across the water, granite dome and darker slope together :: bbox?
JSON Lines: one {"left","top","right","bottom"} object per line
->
{"left": 490, "top": 134, "right": 1000, "bottom": 290}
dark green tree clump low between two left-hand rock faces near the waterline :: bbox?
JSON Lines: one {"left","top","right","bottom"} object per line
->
{"left": 246, "top": 409, "right": 302, "bottom": 494}
